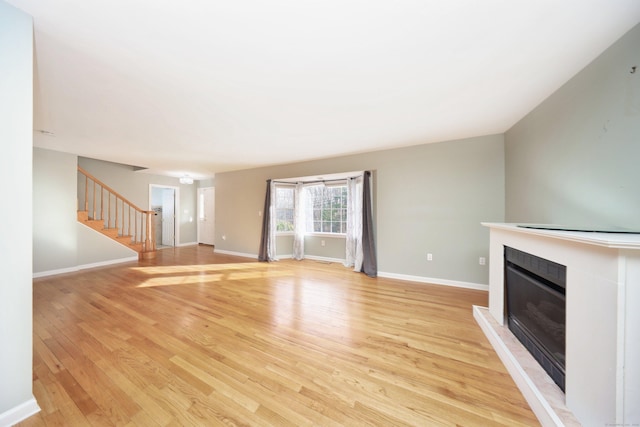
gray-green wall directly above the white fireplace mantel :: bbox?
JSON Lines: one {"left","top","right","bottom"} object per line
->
{"left": 505, "top": 25, "right": 640, "bottom": 229}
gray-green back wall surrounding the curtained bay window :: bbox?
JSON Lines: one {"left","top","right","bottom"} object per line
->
{"left": 216, "top": 135, "right": 504, "bottom": 284}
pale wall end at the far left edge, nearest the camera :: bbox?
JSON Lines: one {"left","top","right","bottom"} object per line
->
{"left": 0, "top": 1, "right": 37, "bottom": 424}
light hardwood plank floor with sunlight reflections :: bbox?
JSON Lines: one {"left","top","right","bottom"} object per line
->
{"left": 19, "top": 246, "right": 539, "bottom": 426}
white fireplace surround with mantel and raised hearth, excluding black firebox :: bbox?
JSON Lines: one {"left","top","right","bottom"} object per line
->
{"left": 474, "top": 223, "right": 640, "bottom": 426}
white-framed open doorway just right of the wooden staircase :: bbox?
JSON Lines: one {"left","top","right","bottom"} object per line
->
{"left": 149, "top": 184, "right": 180, "bottom": 249}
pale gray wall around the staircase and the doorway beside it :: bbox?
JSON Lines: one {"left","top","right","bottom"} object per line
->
{"left": 32, "top": 148, "right": 197, "bottom": 275}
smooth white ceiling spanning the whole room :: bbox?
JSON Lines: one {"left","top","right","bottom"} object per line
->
{"left": 7, "top": 0, "right": 640, "bottom": 179}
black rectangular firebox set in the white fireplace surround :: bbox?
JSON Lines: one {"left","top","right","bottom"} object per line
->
{"left": 504, "top": 246, "right": 566, "bottom": 391}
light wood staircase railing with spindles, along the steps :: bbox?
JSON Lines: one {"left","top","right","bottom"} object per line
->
{"left": 78, "top": 166, "right": 156, "bottom": 259}
